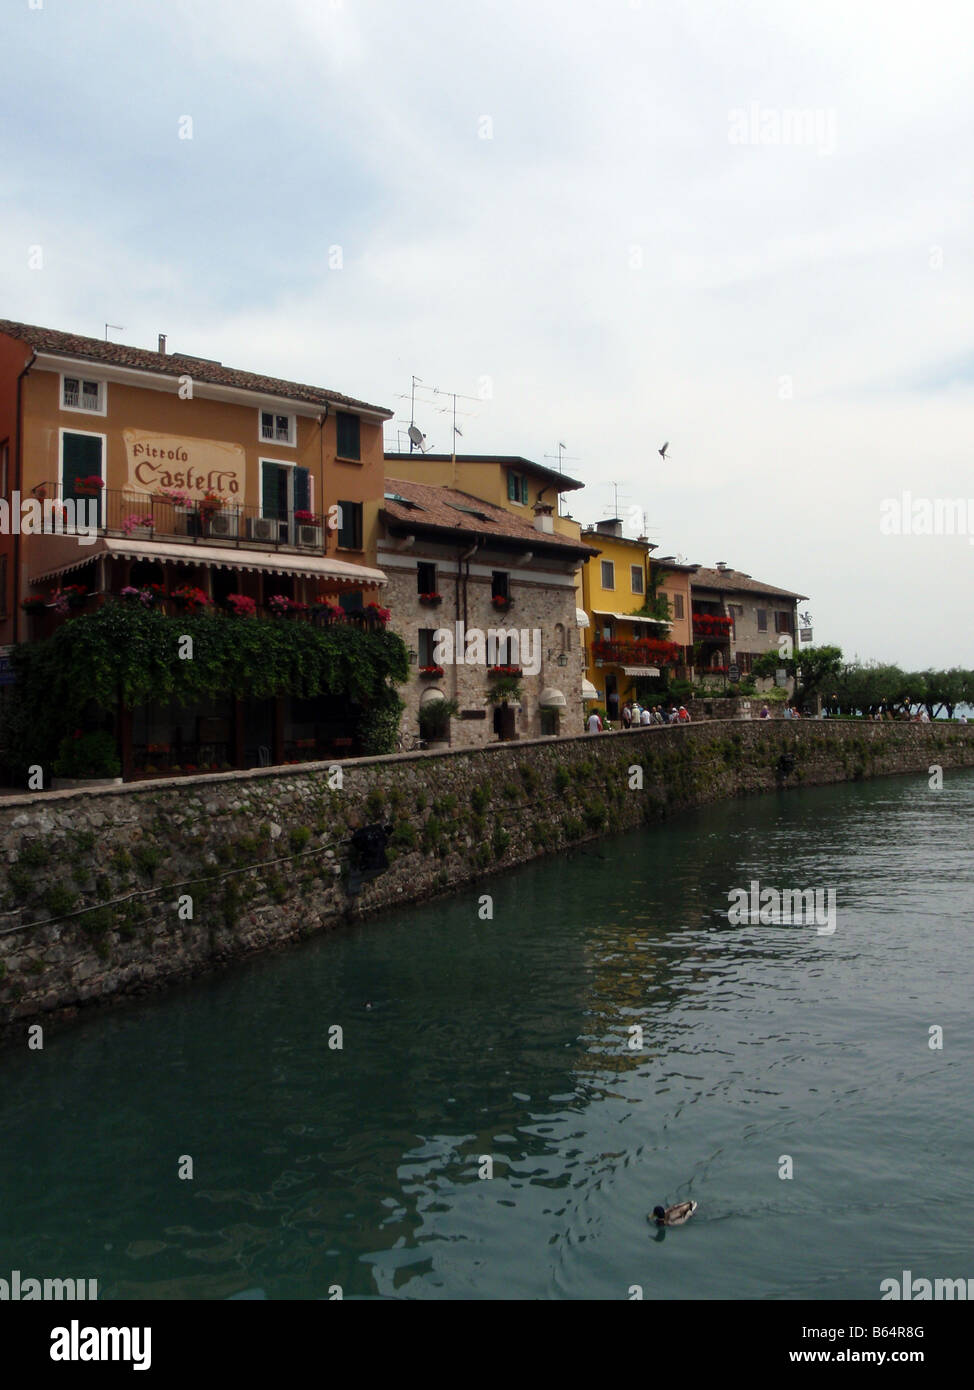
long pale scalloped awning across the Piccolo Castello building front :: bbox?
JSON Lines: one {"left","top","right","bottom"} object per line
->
{"left": 31, "top": 537, "right": 388, "bottom": 588}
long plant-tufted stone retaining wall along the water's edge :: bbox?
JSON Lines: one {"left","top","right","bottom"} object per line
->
{"left": 0, "top": 720, "right": 974, "bottom": 1038}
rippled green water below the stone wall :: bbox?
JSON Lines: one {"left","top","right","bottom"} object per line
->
{"left": 0, "top": 773, "right": 974, "bottom": 1300}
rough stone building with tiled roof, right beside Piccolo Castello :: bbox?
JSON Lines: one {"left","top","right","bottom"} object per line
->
{"left": 378, "top": 478, "right": 593, "bottom": 748}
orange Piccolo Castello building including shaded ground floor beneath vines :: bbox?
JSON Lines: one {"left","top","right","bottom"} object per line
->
{"left": 0, "top": 320, "right": 392, "bottom": 776}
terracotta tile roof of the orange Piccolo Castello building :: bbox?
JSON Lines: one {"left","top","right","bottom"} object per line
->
{"left": 0, "top": 318, "right": 393, "bottom": 420}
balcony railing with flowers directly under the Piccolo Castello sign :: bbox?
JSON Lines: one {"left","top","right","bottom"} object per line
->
{"left": 53, "top": 488, "right": 328, "bottom": 555}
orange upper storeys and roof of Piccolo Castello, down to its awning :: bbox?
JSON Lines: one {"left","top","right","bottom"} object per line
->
{"left": 0, "top": 320, "right": 392, "bottom": 644}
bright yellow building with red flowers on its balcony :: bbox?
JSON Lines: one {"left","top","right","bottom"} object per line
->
{"left": 582, "top": 518, "right": 689, "bottom": 723}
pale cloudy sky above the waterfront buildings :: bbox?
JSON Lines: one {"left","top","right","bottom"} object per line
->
{"left": 0, "top": 0, "right": 974, "bottom": 667}
